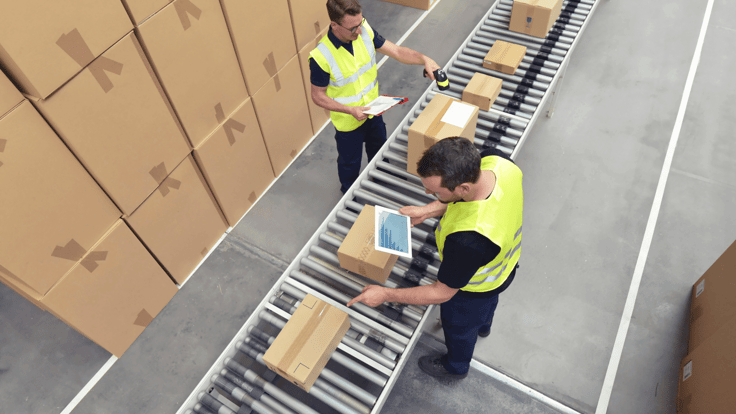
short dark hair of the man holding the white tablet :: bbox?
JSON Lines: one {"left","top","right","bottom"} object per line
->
{"left": 417, "top": 137, "right": 480, "bottom": 191}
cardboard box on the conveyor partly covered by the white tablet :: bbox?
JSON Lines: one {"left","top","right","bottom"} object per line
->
{"left": 337, "top": 205, "right": 399, "bottom": 284}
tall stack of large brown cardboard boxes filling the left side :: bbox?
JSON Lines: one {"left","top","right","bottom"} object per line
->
{"left": 0, "top": 0, "right": 329, "bottom": 356}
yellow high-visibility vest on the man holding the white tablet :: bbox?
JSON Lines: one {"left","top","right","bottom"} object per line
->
{"left": 435, "top": 156, "right": 524, "bottom": 292}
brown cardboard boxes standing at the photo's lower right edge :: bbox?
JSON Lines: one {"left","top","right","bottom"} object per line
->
{"left": 677, "top": 242, "right": 736, "bottom": 414}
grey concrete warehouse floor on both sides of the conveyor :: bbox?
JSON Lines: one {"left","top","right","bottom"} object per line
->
{"left": 0, "top": 0, "right": 736, "bottom": 414}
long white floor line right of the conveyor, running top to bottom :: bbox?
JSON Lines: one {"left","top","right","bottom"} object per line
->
{"left": 595, "top": 0, "right": 713, "bottom": 414}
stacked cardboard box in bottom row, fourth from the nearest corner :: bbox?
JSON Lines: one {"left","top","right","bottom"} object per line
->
{"left": 253, "top": 56, "right": 313, "bottom": 177}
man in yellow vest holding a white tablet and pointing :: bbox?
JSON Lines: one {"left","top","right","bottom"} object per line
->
{"left": 348, "top": 137, "right": 524, "bottom": 378}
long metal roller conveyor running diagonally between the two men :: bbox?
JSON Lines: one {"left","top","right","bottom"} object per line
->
{"left": 177, "top": 0, "right": 598, "bottom": 414}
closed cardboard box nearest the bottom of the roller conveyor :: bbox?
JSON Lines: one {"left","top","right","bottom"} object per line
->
{"left": 263, "top": 294, "right": 350, "bottom": 392}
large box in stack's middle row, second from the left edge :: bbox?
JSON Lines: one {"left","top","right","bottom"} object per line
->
{"left": 34, "top": 33, "right": 190, "bottom": 214}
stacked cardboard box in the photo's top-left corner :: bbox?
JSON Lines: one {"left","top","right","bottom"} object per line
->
{"left": 0, "top": 0, "right": 133, "bottom": 98}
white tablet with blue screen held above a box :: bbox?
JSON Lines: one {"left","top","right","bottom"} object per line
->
{"left": 375, "top": 206, "right": 411, "bottom": 258}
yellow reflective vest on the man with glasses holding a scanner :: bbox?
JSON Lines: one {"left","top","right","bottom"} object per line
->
{"left": 309, "top": 21, "right": 378, "bottom": 132}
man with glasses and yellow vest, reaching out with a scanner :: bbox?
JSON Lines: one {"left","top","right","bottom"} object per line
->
{"left": 309, "top": 0, "right": 439, "bottom": 193}
